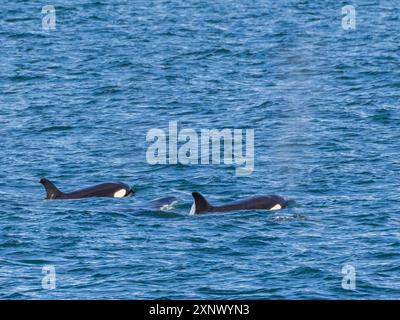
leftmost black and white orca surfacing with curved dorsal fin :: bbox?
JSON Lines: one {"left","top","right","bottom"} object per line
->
{"left": 40, "top": 178, "right": 134, "bottom": 199}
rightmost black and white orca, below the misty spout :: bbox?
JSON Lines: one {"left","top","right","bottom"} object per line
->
{"left": 190, "top": 192, "right": 287, "bottom": 214}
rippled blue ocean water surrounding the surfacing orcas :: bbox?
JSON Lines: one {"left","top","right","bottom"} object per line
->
{"left": 0, "top": 0, "right": 400, "bottom": 299}
